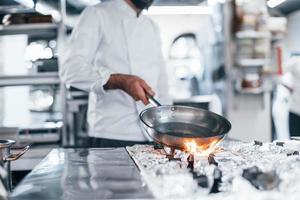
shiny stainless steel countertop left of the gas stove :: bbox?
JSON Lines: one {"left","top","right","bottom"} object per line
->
{"left": 10, "top": 148, "right": 153, "bottom": 200}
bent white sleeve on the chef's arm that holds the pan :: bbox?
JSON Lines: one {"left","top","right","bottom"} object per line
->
{"left": 60, "top": 7, "right": 112, "bottom": 95}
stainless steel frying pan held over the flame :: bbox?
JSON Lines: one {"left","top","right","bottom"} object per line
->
{"left": 140, "top": 97, "right": 231, "bottom": 150}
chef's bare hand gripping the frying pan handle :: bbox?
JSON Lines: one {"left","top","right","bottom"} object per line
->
{"left": 104, "top": 74, "right": 155, "bottom": 105}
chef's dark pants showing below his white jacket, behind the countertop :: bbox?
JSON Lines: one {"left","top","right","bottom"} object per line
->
{"left": 90, "top": 137, "right": 152, "bottom": 148}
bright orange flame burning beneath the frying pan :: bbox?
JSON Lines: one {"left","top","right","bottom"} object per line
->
{"left": 185, "top": 139, "right": 219, "bottom": 156}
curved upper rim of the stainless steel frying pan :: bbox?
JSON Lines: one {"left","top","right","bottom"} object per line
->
{"left": 139, "top": 105, "right": 232, "bottom": 134}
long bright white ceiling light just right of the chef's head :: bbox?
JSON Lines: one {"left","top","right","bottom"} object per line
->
{"left": 144, "top": 6, "right": 212, "bottom": 15}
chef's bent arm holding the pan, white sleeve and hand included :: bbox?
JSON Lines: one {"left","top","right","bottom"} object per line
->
{"left": 60, "top": 7, "right": 154, "bottom": 104}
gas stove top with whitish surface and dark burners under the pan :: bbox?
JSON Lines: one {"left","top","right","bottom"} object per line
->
{"left": 126, "top": 140, "right": 300, "bottom": 200}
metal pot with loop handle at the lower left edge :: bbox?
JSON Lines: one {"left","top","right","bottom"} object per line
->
{"left": 0, "top": 140, "right": 30, "bottom": 191}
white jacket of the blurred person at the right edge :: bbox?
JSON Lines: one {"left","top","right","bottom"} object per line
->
{"left": 284, "top": 56, "right": 300, "bottom": 115}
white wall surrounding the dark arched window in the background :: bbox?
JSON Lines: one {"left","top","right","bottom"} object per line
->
{"left": 150, "top": 14, "right": 222, "bottom": 98}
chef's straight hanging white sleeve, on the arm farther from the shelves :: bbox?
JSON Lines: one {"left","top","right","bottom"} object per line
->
{"left": 154, "top": 25, "right": 173, "bottom": 105}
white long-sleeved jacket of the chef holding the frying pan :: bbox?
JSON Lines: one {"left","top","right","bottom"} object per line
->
{"left": 60, "top": 0, "right": 171, "bottom": 141}
